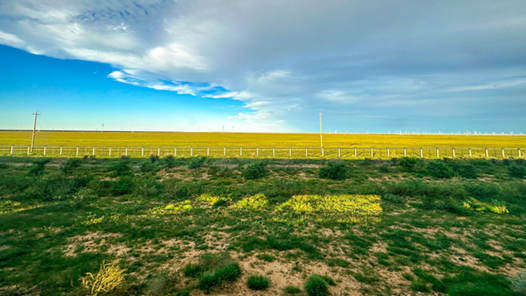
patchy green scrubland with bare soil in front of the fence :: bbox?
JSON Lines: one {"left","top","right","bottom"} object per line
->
{"left": 0, "top": 156, "right": 526, "bottom": 296}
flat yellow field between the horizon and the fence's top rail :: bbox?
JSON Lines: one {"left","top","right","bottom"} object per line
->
{"left": 0, "top": 131, "right": 526, "bottom": 148}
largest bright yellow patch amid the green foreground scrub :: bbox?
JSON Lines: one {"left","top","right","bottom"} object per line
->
{"left": 275, "top": 195, "right": 382, "bottom": 223}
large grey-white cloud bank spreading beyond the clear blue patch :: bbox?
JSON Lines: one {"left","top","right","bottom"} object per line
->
{"left": 0, "top": 0, "right": 526, "bottom": 131}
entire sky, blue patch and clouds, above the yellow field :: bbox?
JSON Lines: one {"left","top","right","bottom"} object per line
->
{"left": 0, "top": 0, "right": 526, "bottom": 134}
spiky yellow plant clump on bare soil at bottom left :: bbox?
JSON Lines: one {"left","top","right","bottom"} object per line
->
{"left": 80, "top": 262, "right": 124, "bottom": 296}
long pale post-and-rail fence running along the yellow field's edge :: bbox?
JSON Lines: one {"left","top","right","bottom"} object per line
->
{"left": 0, "top": 145, "right": 526, "bottom": 159}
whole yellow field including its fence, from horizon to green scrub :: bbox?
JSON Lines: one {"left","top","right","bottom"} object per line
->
{"left": 0, "top": 131, "right": 526, "bottom": 159}
